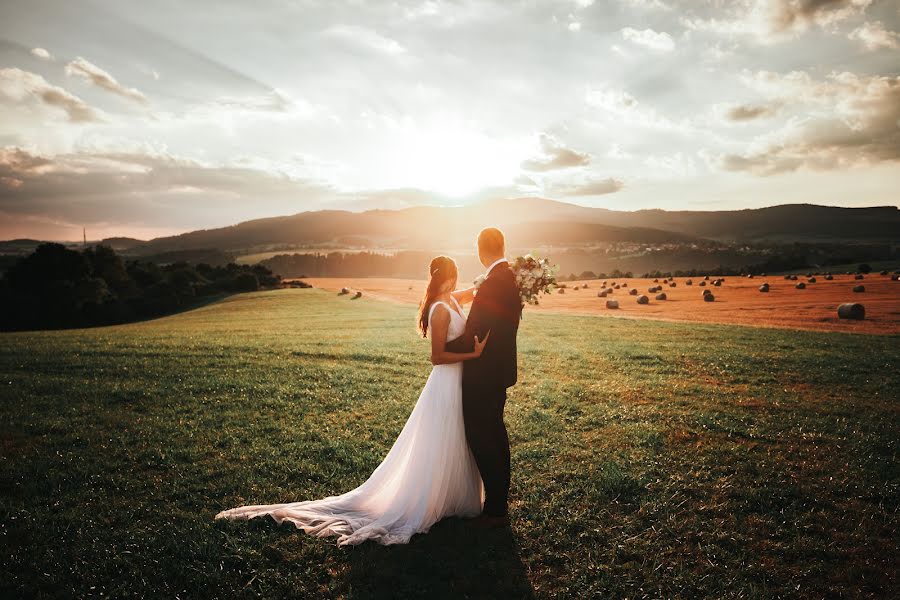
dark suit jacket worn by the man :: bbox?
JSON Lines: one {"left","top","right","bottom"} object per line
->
{"left": 446, "top": 262, "right": 522, "bottom": 388}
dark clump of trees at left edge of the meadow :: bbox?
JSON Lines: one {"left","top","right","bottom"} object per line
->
{"left": 0, "top": 243, "right": 281, "bottom": 331}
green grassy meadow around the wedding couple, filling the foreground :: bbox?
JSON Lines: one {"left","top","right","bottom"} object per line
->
{"left": 0, "top": 290, "right": 900, "bottom": 598}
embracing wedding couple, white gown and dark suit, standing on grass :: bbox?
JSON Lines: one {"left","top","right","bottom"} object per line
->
{"left": 215, "top": 227, "right": 522, "bottom": 546}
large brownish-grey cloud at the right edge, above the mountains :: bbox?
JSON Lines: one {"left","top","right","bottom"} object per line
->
{"left": 718, "top": 71, "right": 900, "bottom": 175}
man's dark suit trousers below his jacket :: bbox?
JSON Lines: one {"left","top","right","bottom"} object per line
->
{"left": 462, "top": 383, "right": 510, "bottom": 517}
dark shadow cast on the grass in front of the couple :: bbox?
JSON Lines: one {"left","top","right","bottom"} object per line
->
{"left": 347, "top": 518, "right": 534, "bottom": 598}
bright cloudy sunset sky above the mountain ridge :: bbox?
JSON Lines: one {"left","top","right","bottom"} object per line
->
{"left": 0, "top": 0, "right": 900, "bottom": 240}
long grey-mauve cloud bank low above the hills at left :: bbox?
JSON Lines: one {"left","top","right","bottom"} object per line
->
{"left": 0, "top": 147, "right": 336, "bottom": 233}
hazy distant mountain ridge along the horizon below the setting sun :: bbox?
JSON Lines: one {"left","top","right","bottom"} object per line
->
{"left": 0, "top": 197, "right": 900, "bottom": 255}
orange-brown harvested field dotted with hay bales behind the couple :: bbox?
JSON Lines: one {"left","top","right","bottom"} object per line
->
{"left": 304, "top": 274, "right": 900, "bottom": 334}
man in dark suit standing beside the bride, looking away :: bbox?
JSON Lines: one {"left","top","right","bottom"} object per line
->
{"left": 447, "top": 227, "right": 522, "bottom": 527}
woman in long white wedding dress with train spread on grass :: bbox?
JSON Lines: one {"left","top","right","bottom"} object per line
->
{"left": 215, "top": 256, "right": 490, "bottom": 546}
